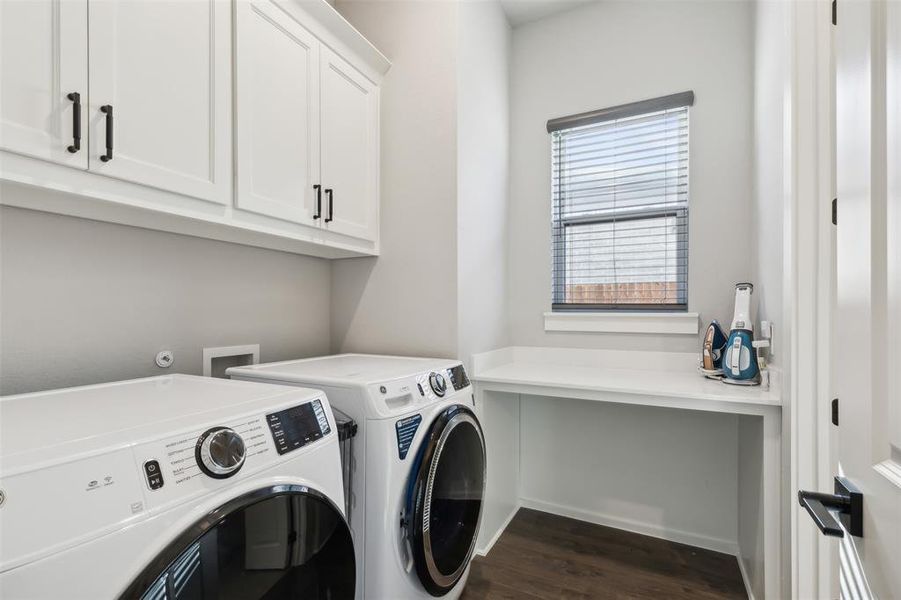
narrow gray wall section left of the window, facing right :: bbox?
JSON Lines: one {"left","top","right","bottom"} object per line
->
{"left": 457, "top": 0, "right": 511, "bottom": 363}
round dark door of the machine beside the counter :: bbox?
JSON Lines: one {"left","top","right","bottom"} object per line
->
{"left": 406, "top": 406, "right": 485, "bottom": 596}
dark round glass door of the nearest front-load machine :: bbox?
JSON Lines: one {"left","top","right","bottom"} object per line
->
{"left": 121, "top": 485, "right": 356, "bottom": 600}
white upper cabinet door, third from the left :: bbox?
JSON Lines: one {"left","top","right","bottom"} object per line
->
{"left": 235, "top": 0, "right": 320, "bottom": 225}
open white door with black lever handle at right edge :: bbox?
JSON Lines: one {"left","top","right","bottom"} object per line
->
{"left": 835, "top": 0, "right": 901, "bottom": 599}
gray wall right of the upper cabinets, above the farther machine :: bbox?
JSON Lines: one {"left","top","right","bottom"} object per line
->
{"left": 332, "top": 0, "right": 458, "bottom": 357}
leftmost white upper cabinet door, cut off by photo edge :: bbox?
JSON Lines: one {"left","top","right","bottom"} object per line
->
{"left": 0, "top": 0, "right": 88, "bottom": 169}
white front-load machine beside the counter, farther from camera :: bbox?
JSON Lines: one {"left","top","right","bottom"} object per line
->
{"left": 228, "top": 354, "right": 485, "bottom": 600}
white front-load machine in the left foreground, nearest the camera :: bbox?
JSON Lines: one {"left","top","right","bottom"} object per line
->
{"left": 0, "top": 375, "right": 355, "bottom": 600}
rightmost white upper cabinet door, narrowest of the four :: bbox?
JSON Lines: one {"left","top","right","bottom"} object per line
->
{"left": 321, "top": 48, "right": 379, "bottom": 240}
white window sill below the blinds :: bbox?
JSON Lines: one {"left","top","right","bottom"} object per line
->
{"left": 544, "top": 311, "right": 698, "bottom": 335}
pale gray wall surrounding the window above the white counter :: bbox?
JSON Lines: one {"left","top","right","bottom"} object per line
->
{"left": 510, "top": 0, "right": 755, "bottom": 351}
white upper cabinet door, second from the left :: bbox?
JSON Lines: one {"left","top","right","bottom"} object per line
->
{"left": 88, "top": 0, "right": 232, "bottom": 204}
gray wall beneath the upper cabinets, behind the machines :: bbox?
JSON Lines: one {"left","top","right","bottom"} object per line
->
{"left": 0, "top": 197, "right": 330, "bottom": 395}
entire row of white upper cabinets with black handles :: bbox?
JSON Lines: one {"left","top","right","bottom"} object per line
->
{"left": 0, "top": 0, "right": 390, "bottom": 258}
